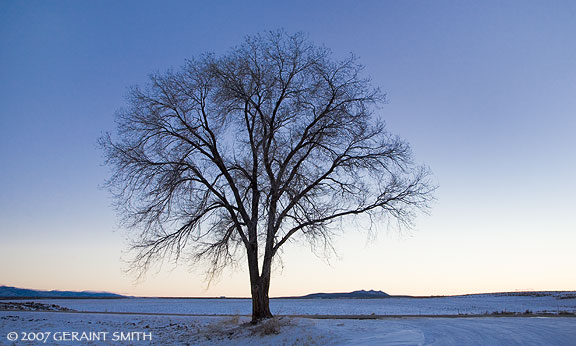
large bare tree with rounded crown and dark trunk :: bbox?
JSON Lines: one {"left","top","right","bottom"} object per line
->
{"left": 100, "top": 32, "right": 432, "bottom": 322}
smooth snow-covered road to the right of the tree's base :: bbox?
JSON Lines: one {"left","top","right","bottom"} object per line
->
{"left": 317, "top": 317, "right": 576, "bottom": 346}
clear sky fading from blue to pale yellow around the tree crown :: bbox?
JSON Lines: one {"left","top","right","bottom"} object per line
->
{"left": 0, "top": 0, "right": 576, "bottom": 296}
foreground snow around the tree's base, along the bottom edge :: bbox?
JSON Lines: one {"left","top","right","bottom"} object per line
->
{"left": 0, "top": 311, "right": 576, "bottom": 346}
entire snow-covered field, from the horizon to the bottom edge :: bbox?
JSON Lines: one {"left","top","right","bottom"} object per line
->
{"left": 0, "top": 292, "right": 576, "bottom": 345}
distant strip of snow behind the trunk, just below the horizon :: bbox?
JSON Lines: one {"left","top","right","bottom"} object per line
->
{"left": 5, "top": 292, "right": 576, "bottom": 315}
